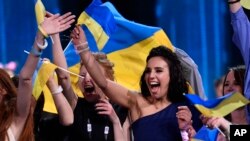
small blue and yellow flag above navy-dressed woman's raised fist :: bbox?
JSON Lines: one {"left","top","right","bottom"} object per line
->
{"left": 77, "top": 0, "right": 116, "bottom": 50}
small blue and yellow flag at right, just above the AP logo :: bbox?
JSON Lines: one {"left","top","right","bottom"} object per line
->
{"left": 185, "top": 92, "right": 249, "bottom": 117}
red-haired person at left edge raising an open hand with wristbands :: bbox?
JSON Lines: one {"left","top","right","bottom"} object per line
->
{"left": 0, "top": 13, "right": 74, "bottom": 141}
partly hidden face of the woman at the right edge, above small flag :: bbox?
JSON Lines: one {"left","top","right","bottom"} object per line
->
{"left": 224, "top": 70, "right": 242, "bottom": 94}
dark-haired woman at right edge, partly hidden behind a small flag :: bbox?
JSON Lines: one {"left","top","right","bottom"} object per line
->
{"left": 202, "top": 65, "right": 248, "bottom": 141}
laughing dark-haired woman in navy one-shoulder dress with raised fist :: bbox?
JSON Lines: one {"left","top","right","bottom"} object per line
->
{"left": 71, "top": 27, "right": 202, "bottom": 141}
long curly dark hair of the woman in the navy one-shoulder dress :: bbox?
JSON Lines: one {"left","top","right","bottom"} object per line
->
{"left": 140, "top": 46, "right": 188, "bottom": 102}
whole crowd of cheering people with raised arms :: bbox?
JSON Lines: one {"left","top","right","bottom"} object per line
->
{"left": 0, "top": 0, "right": 250, "bottom": 141}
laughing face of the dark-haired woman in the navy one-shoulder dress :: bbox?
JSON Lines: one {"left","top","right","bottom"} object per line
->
{"left": 145, "top": 57, "right": 170, "bottom": 99}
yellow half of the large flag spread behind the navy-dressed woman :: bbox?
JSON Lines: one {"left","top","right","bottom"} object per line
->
{"left": 107, "top": 30, "right": 174, "bottom": 91}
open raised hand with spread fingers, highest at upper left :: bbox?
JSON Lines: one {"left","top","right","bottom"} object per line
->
{"left": 40, "top": 12, "right": 75, "bottom": 35}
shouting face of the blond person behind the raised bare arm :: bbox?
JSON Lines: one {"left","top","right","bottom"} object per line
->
{"left": 78, "top": 66, "right": 104, "bottom": 102}
